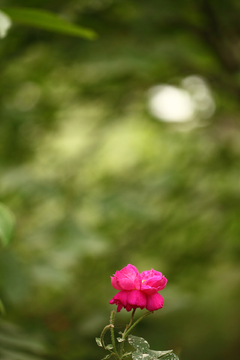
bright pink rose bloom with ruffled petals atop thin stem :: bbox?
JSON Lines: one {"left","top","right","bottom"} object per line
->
{"left": 109, "top": 264, "right": 167, "bottom": 312}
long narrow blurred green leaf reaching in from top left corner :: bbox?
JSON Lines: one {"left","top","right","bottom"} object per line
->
{"left": 1, "top": 8, "right": 97, "bottom": 40}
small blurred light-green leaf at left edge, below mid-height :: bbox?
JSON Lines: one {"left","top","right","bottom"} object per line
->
{"left": 0, "top": 204, "right": 15, "bottom": 245}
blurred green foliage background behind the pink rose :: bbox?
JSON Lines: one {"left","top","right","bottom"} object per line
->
{"left": 0, "top": 0, "right": 240, "bottom": 360}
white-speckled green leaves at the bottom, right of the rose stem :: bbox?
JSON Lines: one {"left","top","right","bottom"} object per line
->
{"left": 128, "top": 335, "right": 178, "bottom": 360}
